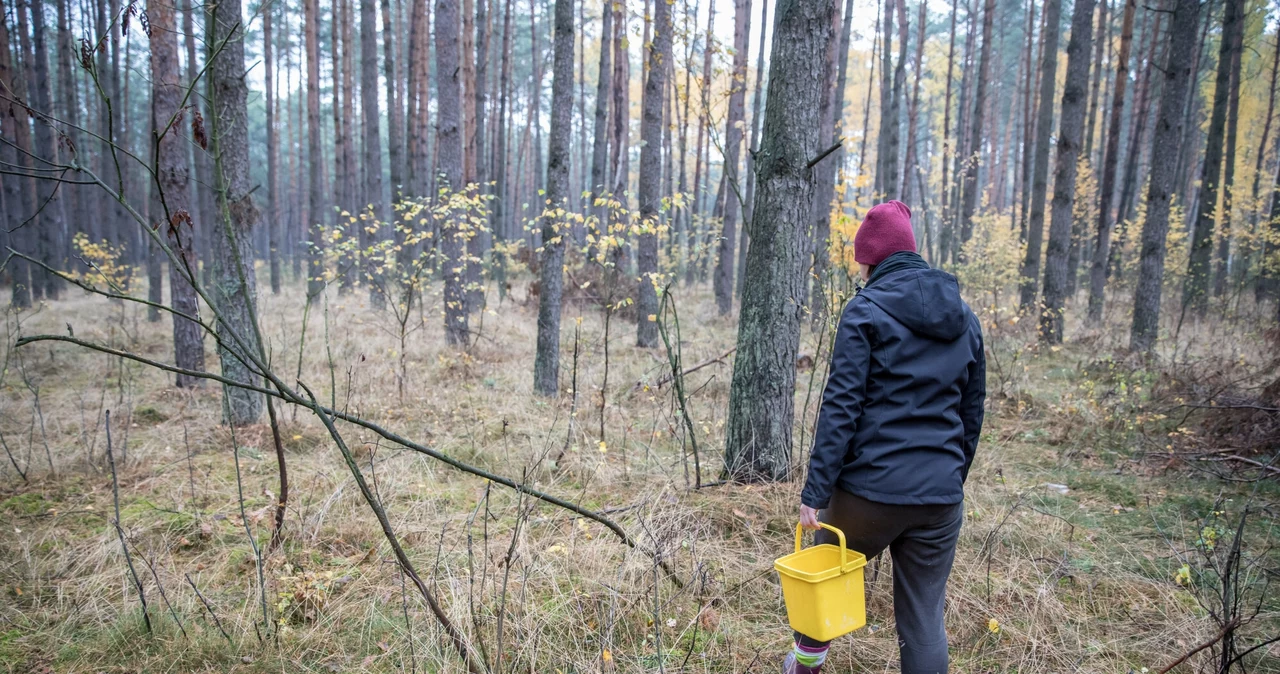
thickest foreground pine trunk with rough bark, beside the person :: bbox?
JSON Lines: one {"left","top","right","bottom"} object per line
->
{"left": 724, "top": 0, "right": 837, "bottom": 481}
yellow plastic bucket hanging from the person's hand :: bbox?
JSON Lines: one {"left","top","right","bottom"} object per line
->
{"left": 773, "top": 524, "right": 867, "bottom": 641}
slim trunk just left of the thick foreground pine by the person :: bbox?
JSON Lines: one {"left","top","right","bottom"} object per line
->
{"left": 711, "top": 0, "right": 747, "bottom": 316}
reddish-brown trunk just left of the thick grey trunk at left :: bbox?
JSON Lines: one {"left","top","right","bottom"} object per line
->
{"left": 147, "top": 3, "right": 204, "bottom": 389}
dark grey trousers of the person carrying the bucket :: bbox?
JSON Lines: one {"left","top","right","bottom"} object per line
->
{"left": 797, "top": 489, "right": 964, "bottom": 674}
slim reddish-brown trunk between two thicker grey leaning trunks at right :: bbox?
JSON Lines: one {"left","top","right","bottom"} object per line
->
{"left": 1087, "top": 0, "right": 1138, "bottom": 325}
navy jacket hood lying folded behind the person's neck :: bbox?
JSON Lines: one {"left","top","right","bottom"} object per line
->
{"left": 859, "top": 259, "right": 970, "bottom": 341}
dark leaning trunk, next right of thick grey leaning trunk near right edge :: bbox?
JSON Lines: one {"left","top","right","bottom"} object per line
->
{"left": 1183, "top": 0, "right": 1244, "bottom": 313}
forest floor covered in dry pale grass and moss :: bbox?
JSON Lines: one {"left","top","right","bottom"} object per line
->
{"left": 0, "top": 276, "right": 1280, "bottom": 674}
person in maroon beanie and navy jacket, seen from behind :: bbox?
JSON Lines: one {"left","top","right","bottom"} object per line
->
{"left": 783, "top": 201, "right": 987, "bottom": 674}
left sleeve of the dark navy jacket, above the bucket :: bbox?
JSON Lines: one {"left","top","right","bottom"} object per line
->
{"left": 800, "top": 297, "right": 873, "bottom": 509}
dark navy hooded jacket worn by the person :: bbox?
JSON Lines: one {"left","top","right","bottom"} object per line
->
{"left": 800, "top": 253, "right": 987, "bottom": 509}
